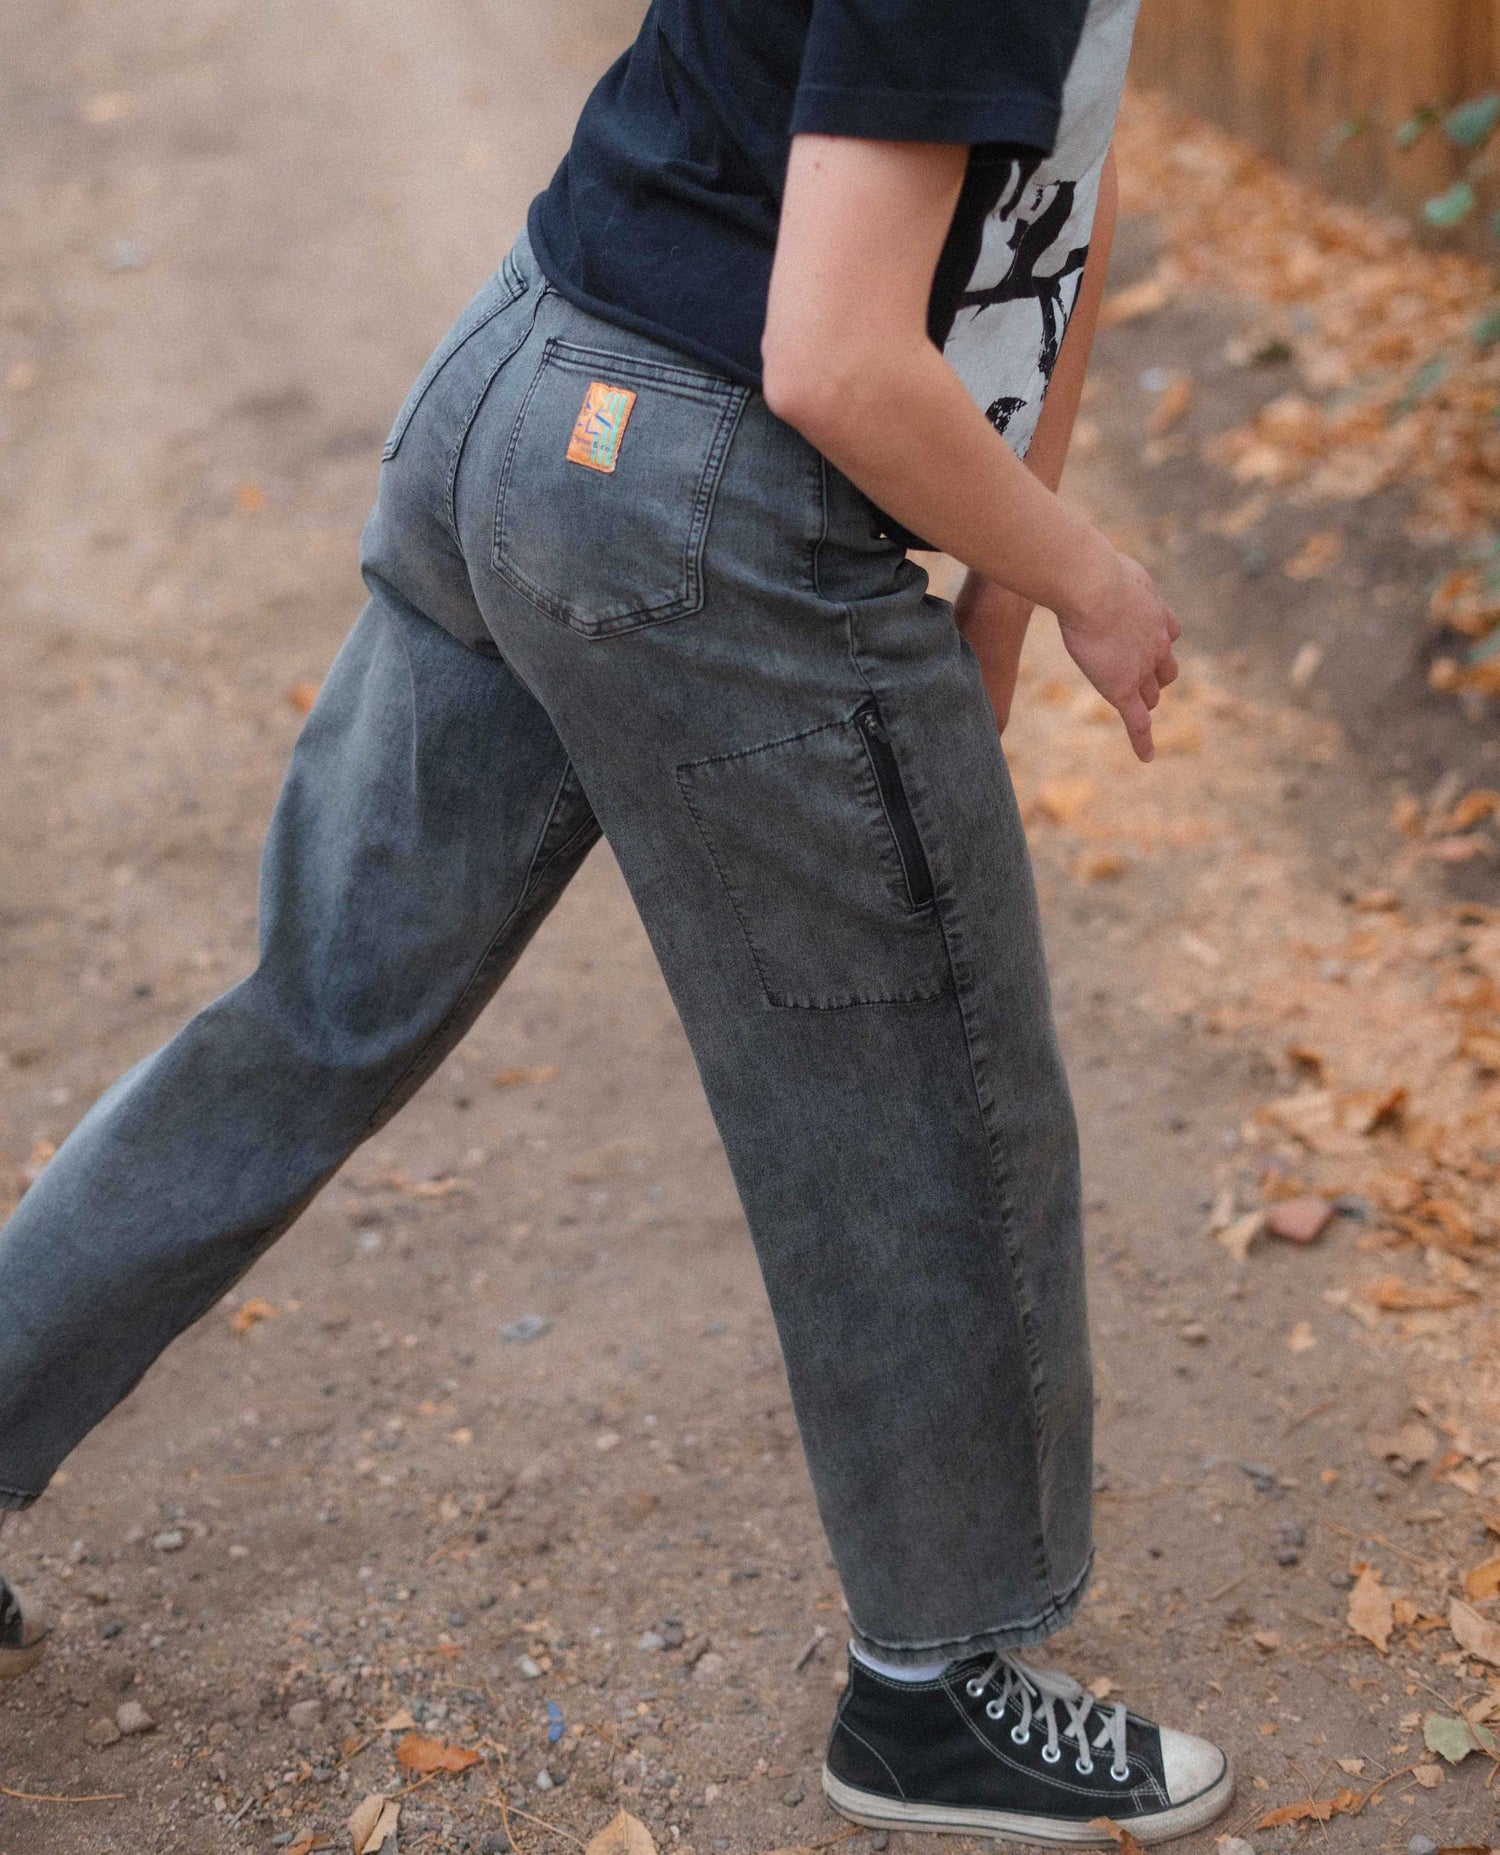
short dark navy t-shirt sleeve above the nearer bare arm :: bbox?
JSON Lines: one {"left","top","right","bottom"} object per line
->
{"left": 792, "top": 0, "right": 1088, "bottom": 154}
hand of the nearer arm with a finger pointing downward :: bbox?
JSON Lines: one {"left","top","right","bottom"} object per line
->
{"left": 1057, "top": 547, "right": 1183, "bottom": 761}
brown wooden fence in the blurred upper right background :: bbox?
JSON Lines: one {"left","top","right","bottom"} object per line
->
{"left": 1131, "top": 0, "right": 1500, "bottom": 228}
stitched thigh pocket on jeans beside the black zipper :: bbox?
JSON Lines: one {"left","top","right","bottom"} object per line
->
{"left": 677, "top": 701, "right": 949, "bottom": 1011}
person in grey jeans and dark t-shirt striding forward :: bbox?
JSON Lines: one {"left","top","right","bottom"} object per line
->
{"left": 0, "top": 0, "right": 1231, "bottom": 1842}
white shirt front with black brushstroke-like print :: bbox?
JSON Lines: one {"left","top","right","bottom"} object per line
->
{"left": 944, "top": 0, "right": 1140, "bottom": 456}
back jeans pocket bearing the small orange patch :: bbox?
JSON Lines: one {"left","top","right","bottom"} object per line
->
{"left": 493, "top": 338, "right": 749, "bottom": 638}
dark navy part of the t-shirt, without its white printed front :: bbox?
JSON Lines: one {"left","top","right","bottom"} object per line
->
{"left": 528, "top": 0, "right": 1090, "bottom": 386}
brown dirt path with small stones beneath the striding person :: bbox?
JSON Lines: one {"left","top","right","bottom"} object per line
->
{"left": 0, "top": 0, "right": 1500, "bottom": 1855}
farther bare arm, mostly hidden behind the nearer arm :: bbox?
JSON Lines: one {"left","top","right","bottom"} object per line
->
{"left": 953, "top": 148, "right": 1120, "bottom": 733}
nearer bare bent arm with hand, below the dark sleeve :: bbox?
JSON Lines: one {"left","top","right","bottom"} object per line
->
{"left": 762, "top": 135, "right": 1177, "bottom": 759}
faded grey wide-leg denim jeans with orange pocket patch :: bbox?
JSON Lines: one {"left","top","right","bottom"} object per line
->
{"left": 0, "top": 239, "right": 1092, "bottom": 1660}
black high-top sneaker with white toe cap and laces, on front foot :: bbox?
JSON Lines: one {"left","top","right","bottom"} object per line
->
{"left": 823, "top": 1653, "right": 1235, "bottom": 1848}
